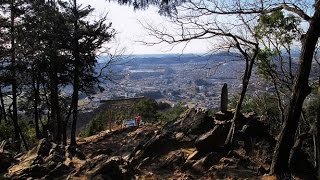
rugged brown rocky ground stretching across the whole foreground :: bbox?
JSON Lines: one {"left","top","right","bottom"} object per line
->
{"left": 0, "top": 109, "right": 312, "bottom": 180}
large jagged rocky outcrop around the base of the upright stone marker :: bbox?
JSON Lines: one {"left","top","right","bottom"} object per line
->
{"left": 129, "top": 109, "right": 275, "bottom": 178}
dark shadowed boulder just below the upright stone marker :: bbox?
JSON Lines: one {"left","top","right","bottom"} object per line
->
{"left": 195, "top": 125, "right": 229, "bottom": 153}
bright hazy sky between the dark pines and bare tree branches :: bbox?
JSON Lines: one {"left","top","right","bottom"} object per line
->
{"left": 78, "top": 0, "right": 208, "bottom": 54}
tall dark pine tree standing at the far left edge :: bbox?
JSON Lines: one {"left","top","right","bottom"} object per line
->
{"left": 0, "top": 0, "right": 28, "bottom": 150}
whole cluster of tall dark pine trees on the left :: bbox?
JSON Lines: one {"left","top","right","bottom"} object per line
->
{"left": 0, "top": 0, "right": 115, "bottom": 150}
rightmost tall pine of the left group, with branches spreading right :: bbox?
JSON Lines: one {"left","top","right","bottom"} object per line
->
{"left": 60, "top": 0, "right": 114, "bottom": 145}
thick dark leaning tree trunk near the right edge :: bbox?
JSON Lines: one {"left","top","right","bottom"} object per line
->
{"left": 270, "top": 9, "right": 320, "bottom": 175}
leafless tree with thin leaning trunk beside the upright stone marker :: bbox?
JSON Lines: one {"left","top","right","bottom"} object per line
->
{"left": 144, "top": 1, "right": 259, "bottom": 145}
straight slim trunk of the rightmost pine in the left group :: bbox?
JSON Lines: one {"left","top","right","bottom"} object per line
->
{"left": 71, "top": 0, "right": 80, "bottom": 146}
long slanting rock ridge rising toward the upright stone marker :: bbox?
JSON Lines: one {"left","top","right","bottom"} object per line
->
{"left": 130, "top": 109, "right": 214, "bottom": 164}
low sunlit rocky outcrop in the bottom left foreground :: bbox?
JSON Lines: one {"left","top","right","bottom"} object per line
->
{"left": 5, "top": 139, "right": 134, "bottom": 180}
